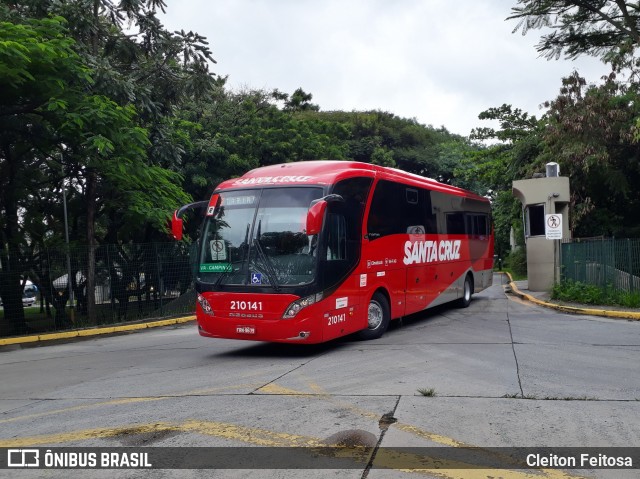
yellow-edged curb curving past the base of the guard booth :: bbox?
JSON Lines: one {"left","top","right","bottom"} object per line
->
{"left": 504, "top": 273, "right": 640, "bottom": 321}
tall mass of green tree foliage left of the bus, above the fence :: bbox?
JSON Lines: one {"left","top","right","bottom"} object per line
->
{"left": 0, "top": 0, "right": 213, "bottom": 330}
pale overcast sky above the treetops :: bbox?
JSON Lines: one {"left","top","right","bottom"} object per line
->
{"left": 162, "top": 0, "right": 607, "bottom": 135}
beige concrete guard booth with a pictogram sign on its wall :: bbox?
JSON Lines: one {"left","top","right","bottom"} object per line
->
{"left": 512, "top": 163, "right": 570, "bottom": 291}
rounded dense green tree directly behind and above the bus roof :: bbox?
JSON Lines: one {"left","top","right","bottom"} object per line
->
{"left": 176, "top": 88, "right": 349, "bottom": 208}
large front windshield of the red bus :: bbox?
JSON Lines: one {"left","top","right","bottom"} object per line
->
{"left": 198, "top": 187, "right": 322, "bottom": 291}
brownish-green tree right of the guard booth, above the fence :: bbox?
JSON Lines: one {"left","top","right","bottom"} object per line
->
{"left": 541, "top": 72, "right": 640, "bottom": 236}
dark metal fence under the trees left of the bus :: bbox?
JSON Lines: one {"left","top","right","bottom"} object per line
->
{"left": 0, "top": 243, "right": 195, "bottom": 336}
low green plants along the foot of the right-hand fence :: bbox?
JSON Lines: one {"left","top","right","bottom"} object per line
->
{"left": 551, "top": 280, "right": 640, "bottom": 308}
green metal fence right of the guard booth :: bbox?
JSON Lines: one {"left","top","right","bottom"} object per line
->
{"left": 561, "top": 238, "right": 640, "bottom": 291}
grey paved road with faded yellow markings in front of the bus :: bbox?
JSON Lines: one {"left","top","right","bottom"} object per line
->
{"left": 0, "top": 276, "right": 640, "bottom": 479}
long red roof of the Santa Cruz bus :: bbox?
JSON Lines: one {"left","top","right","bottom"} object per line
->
{"left": 216, "top": 160, "right": 488, "bottom": 201}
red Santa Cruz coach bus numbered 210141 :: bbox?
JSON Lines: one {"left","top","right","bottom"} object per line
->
{"left": 172, "top": 161, "right": 493, "bottom": 343}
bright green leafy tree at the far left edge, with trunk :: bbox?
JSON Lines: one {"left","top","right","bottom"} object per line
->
{"left": 0, "top": 11, "right": 96, "bottom": 333}
